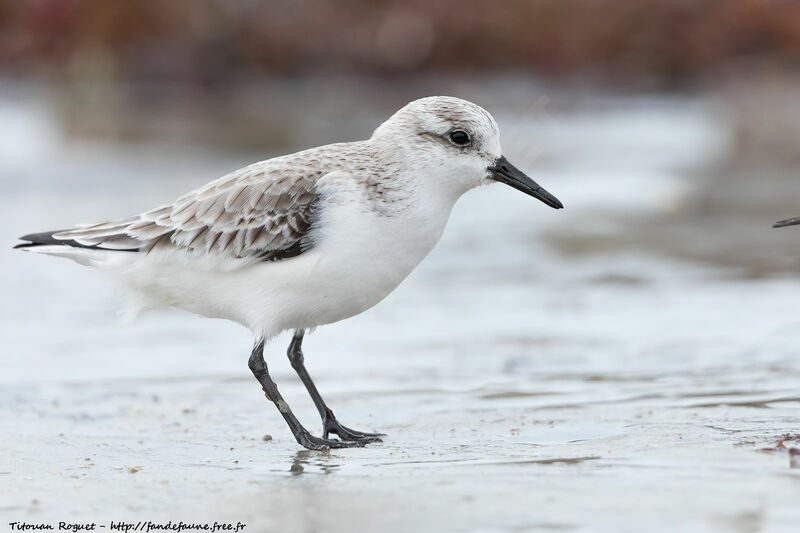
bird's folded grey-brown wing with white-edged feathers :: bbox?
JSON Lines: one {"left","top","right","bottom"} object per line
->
{"left": 23, "top": 162, "right": 322, "bottom": 260}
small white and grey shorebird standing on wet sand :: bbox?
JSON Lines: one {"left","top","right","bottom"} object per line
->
{"left": 15, "top": 96, "right": 564, "bottom": 450}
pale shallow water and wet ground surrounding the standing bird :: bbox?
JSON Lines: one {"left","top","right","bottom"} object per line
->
{"left": 0, "top": 85, "right": 800, "bottom": 532}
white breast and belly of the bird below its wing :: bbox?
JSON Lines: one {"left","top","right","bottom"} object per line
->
{"left": 123, "top": 187, "right": 452, "bottom": 338}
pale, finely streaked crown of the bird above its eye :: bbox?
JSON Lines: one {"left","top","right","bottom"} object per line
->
{"left": 376, "top": 96, "right": 499, "bottom": 138}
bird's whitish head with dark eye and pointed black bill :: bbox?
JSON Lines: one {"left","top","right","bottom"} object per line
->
{"left": 370, "top": 96, "right": 564, "bottom": 209}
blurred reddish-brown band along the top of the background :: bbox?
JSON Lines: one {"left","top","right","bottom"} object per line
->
{"left": 0, "top": 0, "right": 800, "bottom": 83}
